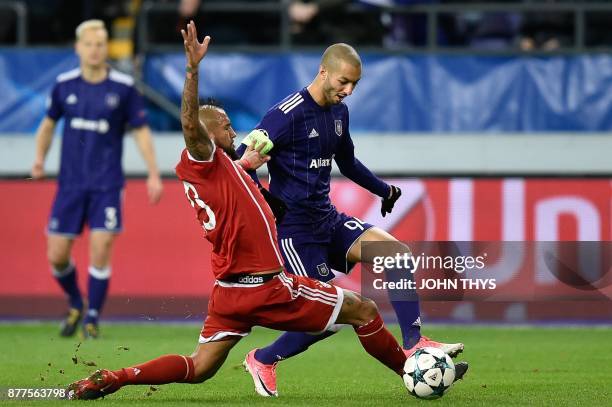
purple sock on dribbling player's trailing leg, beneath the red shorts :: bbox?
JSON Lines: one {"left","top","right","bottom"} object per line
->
{"left": 255, "top": 331, "right": 336, "bottom": 365}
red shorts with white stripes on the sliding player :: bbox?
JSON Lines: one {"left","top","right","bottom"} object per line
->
{"left": 200, "top": 272, "right": 344, "bottom": 343}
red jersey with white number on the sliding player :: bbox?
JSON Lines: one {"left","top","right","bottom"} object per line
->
{"left": 176, "top": 147, "right": 283, "bottom": 279}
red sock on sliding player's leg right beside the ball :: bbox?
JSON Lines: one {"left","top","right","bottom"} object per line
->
{"left": 353, "top": 315, "right": 406, "bottom": 375}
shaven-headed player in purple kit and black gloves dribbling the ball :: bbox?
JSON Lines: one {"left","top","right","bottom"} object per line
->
{"left": 238, "top": 43, "right": 463, "bottom": 392}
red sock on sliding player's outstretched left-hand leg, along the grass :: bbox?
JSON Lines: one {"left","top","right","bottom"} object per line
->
{"left": 113, "top": 355, "right": 195, "bottom": 386}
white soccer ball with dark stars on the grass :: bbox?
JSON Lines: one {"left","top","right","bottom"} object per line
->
{"left": 403, "top": 347, "right": 455, "bottom": 399}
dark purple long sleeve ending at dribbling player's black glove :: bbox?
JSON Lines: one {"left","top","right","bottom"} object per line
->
{"left": 334, "top": 111, "right": 390, "bottom": 198}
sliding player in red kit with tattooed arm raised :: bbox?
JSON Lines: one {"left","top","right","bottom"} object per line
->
{"left": 68, "top": 22, "right": 454, "bottom": 399}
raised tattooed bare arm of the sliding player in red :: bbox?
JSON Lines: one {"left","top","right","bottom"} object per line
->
{"left": 181, "top": 21, "right": 213, "bottom": 160}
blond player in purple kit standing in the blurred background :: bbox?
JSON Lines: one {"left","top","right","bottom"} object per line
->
{"left": 32, "top": 20, "right": 162, "bottom": 338}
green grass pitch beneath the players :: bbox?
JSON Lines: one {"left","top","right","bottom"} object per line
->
{"left": 0, "top": 323, "right": 612, "bottom": 406}
